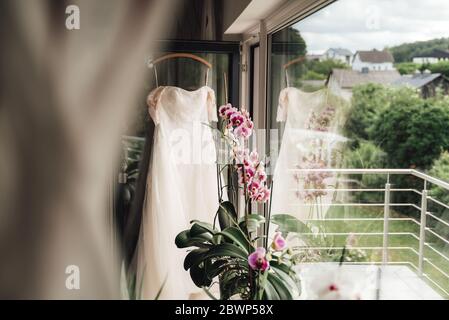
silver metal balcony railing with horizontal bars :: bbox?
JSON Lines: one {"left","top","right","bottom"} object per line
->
{"left": 290, "top": 169, "right": 449, "bottom": 297}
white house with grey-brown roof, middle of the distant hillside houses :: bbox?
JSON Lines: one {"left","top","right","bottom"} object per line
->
{"left": 352, "top": 49, "right": 395, "bottom": 72}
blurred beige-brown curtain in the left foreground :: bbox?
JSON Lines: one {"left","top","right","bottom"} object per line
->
{"left": 0, "top": 0, "right": 175, "bottom": 299}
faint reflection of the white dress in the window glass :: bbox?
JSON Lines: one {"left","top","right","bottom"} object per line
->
{"left": 272, "top": 88, "right": 345, "bottom": 220}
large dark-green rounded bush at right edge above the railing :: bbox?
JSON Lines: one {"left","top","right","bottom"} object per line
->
{"left": 371, "top": 88, "right": 449, "bottom": 169}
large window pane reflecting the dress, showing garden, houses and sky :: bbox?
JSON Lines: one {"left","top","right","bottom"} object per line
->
{"left": 267, "top": 0, "right": 449, "bottom": 298}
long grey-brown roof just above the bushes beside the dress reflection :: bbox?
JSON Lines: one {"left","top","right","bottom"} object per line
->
{"left": 330, "top": 69, "right": 401, "bottom": 89}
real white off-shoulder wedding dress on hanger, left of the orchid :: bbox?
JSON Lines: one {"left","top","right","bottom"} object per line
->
{"left": 136, "top": 86, "right": 218, "bottom": 300}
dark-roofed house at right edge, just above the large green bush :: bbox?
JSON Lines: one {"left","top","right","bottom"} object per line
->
{"left": 392, "top": 70, "right": 449, "bottom": 98}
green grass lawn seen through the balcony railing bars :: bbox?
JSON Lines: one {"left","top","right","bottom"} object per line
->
{"left": 298, "top": 207, "right": 449, "bottom": 299}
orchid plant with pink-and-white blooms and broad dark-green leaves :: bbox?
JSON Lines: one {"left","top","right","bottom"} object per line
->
{"left": 175, "top": 104, "right": 300, "bottom": 300}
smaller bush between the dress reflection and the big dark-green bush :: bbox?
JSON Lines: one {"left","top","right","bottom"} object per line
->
{"left": 345, "top": 83, "right": 390, "bottom": 144}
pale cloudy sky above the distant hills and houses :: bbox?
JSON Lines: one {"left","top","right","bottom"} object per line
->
{"left": 294, "top": 0, "right": 449, "bottom": 53}
